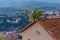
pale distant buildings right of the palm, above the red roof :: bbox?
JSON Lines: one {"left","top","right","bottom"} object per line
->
{"left": 42, "top": 10, "right": 60, "bottom": 18}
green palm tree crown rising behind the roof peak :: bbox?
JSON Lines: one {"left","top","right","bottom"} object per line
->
{"left": 28, "top": 9, "right": 44, "bottom": 21}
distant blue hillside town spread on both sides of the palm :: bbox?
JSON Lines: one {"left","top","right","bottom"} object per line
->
{"left": 0, "top": 8, "right": 60, "bottom": 31}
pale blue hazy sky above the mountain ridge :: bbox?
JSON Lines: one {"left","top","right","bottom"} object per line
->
{"left": 0, "top": 0, "right": 60, "bottom": 7}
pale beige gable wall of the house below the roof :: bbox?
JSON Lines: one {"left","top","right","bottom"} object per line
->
{"left": 21, "top": 23, "right": 53, "bottom": 40}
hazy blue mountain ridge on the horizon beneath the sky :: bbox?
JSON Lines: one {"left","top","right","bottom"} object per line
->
{"left": 17, "top": 1, "right": 60, "bottom": 8}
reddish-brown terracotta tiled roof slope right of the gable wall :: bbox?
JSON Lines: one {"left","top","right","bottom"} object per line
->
{"left": 39, "top": 18, "right": 60, "bottom": 40}
